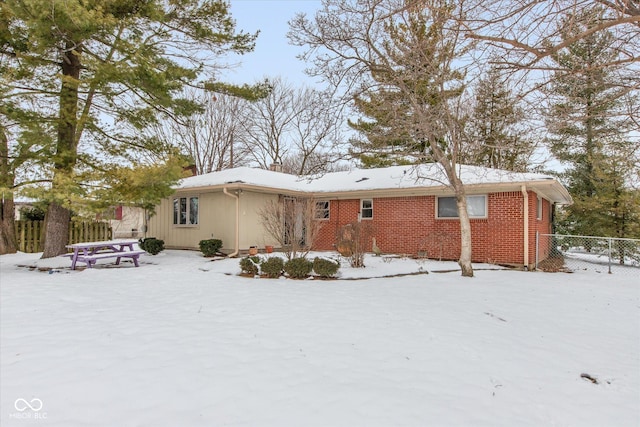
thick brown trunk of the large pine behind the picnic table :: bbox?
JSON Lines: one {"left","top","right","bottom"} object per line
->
{"left": 42, "top": 41, "right": 82, "bottom": 258}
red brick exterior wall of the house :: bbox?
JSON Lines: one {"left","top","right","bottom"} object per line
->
{"left": 314, "top": 191, "right": 551, "bottom": 265}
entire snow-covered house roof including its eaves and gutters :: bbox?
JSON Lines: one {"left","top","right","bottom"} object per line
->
{"left": 176, "top": 163, "right": 571, "bottom": 204}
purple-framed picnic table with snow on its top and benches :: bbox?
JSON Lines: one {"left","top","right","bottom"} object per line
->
{"left": 65, "top": 239, "right": 145, "bottom": 270}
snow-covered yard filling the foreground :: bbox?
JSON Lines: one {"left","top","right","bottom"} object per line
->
{"left": 0, "top": 251, "right": 640, "bottom": 427}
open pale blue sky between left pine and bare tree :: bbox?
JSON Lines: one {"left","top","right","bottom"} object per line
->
{"left": 221, "top": 0, "right": 321, "bottom": 84}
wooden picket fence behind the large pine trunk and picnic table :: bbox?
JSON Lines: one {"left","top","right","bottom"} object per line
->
{"left": 15, "top": 221, "right": 113, "bottom": 253}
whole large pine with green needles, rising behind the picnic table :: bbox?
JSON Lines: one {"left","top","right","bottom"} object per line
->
{"left": 0, "top": 0, "right": 256, "bottom": 257}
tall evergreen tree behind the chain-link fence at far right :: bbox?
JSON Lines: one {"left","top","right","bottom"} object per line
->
{"left": 547, "top": 11, "right": 640, "bottom": 241}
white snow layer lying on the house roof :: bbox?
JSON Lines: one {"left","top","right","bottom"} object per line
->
{"left": 177, "top": 163, "right": 554, "bottom": 193}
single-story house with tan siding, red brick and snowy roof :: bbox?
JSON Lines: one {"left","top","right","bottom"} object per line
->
{"left": 148, "top": 164, "right": 571, "bottom": 267}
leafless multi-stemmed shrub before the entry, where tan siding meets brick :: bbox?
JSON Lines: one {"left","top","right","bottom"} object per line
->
{"left": 259, "top": 196, "right": 323, "bottom": 259}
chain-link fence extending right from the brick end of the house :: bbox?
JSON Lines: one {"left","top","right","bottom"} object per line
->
{"left": 536, "top": 234, "right": 640, "bottom": 274}
